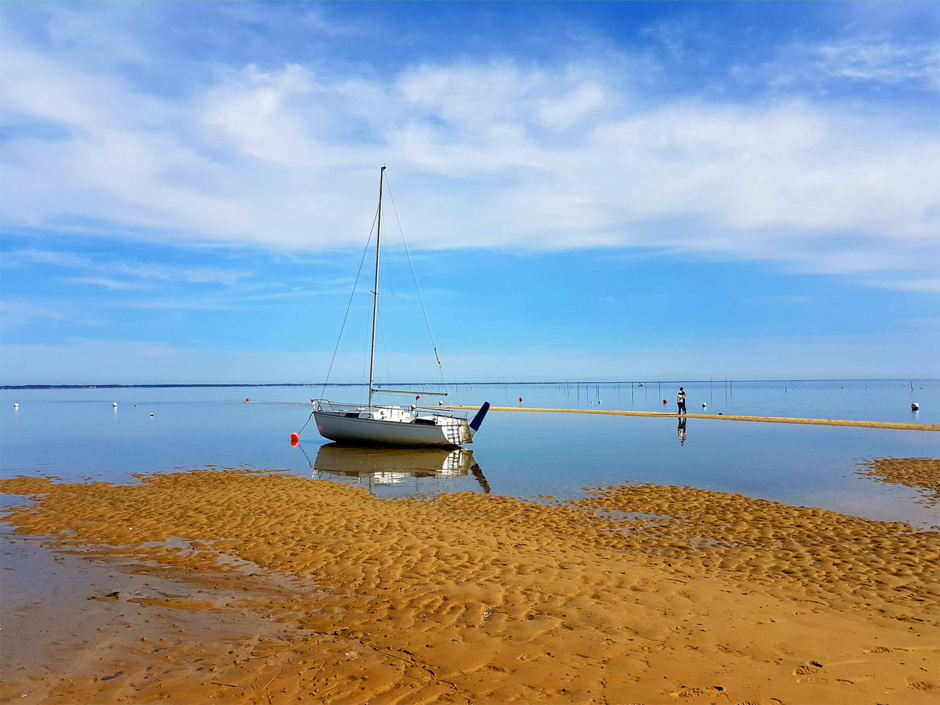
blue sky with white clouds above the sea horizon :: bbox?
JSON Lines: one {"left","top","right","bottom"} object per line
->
{"left": 0, "top": 2, "right": 940, "bottom": 384}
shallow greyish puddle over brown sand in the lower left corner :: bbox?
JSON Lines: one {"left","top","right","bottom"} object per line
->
{"left": 0, "top": 525, "right": 313, "bottom": 703}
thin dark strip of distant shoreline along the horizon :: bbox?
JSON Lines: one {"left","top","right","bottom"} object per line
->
{"left": 0, "top": 377, "right": 938, "bottom": 390}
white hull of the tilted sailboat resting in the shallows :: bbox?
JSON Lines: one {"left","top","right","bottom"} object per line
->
{"left": 314, "top": 411, "right": 473, "bottom": 446}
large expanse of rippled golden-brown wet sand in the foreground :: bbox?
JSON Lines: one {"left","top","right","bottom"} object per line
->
{"left": 0, "top": 471, "right": 940, "bottom": 704}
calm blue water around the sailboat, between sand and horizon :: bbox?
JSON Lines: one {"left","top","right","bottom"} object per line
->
{"left": 0, "top": 380, "right": 940, "bottom": 526}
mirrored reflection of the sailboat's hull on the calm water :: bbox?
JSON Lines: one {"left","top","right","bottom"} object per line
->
{"left": 313, "top": 443, "right": 490, "bottom": 494}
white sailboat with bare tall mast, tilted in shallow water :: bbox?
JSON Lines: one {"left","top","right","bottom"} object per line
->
{"left": 313, "top": 166, "right": 490, "bottom": 446}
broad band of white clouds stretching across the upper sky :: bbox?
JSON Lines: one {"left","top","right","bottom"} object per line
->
{"left": 0, "top": 10, "right": 940, "bottom": 288}
